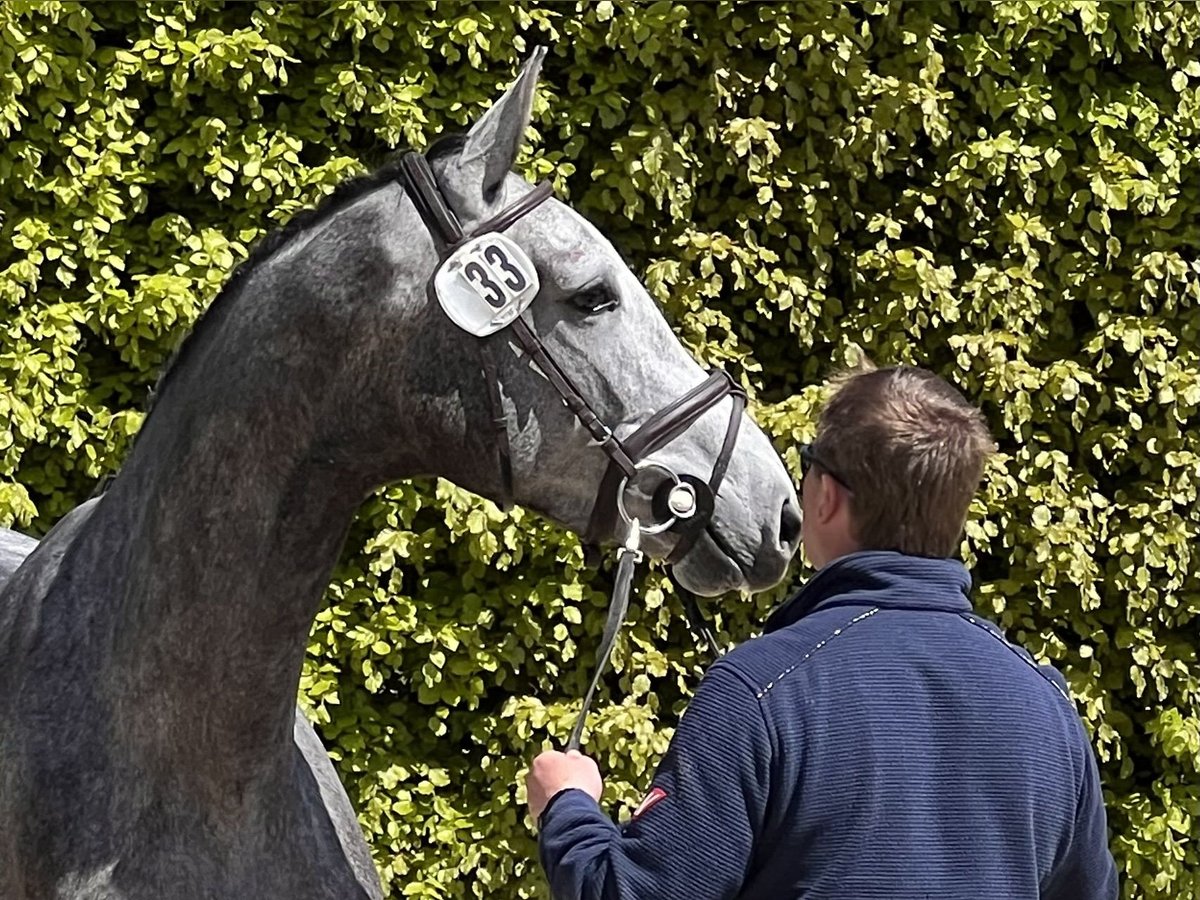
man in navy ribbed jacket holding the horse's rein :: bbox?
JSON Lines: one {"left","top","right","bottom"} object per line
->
{"left": 528, "top": 367, "right": 1117, "bottom": 900}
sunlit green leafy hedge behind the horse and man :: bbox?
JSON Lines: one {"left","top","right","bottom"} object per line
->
{"left": 0, "top": 0, "right": 1200, "bottom": 900}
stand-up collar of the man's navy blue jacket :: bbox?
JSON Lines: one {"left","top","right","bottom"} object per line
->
{"left": 764, "top": 550, "right": 971, "bottom": 634}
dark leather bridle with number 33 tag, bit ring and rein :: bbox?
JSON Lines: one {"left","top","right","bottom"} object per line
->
{"left": 400, "top": 152, "right": 729, "bottom": 746}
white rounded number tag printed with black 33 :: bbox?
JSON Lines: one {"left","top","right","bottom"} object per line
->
{"left": 433, "top": 233, "right": 539, "bottom": 337}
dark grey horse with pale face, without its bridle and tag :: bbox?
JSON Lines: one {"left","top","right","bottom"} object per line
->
{"left": 0, "top": 52, "right": 798, "bottom": 900}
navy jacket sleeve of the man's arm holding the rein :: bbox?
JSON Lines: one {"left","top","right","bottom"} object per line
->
{"left": 539, "top": 662, "right": 772, "bottom": 900}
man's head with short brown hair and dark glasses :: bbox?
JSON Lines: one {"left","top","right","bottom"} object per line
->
{"left": 802, "top": 366, "right": 995, "bottom": 569}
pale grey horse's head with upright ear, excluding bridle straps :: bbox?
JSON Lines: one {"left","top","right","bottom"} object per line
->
{"left": 417, "top": 52, "right": 799, "bottom": 595}
